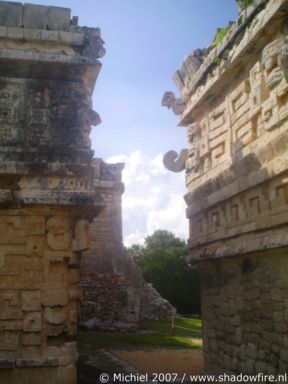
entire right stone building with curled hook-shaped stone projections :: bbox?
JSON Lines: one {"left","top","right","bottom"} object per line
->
{"left": 163, "top": 0, "right": 288, "bottom": 374}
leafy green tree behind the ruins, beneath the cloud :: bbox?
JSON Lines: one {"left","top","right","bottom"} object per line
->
{"left": 128, "top": 230, "right": 200, "bottom": 314}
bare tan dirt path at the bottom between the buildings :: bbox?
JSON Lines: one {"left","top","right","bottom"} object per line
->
{"left": 113, "top": 349, "right": 203, "bottom": 375}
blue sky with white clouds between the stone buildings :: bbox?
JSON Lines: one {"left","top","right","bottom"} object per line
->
{"left": 23, "top": 0, "right": 238, "bottom": 245}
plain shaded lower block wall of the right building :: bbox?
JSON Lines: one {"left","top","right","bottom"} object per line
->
{"left": 201, "top": 251, "right": 288, "bottom": 375}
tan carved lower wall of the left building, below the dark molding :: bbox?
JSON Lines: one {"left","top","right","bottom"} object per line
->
{"left": 0, "top": 206, "right": 81, "bottom": 383}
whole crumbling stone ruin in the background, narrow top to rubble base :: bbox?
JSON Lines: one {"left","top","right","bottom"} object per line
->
{"left": 80, "top": 160, "right": 175, "bottom": 330}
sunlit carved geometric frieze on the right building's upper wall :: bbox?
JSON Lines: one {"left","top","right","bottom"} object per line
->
{"left": 182, "top": 39, "right": 288, "bottom": 196}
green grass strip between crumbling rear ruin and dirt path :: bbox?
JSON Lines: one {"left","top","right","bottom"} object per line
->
{"left": 78, "top": 319, "right": 202, "bottom": 350}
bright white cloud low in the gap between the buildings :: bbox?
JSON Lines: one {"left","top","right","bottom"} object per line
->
{"left": 107, "top": 150, "right": 188, "bottom": 246}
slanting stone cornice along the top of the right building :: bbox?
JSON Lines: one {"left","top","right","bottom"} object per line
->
{"left": 178, "top": 0, "right": 288, "bottom": 126}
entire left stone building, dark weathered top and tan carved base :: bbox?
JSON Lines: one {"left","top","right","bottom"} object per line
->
{"left": 0, "top": 2, "right": 105, "bottom": 384}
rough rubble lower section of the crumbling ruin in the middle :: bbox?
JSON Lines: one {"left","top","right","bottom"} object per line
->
{"left": 80, "top": 262, "right": 176, "bottom": 331}
